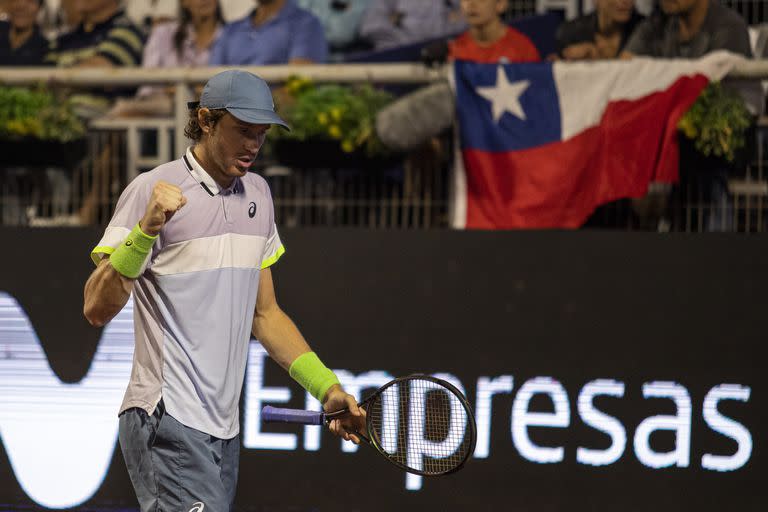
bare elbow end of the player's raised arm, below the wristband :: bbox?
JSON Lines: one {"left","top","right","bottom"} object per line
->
{"left": 83, "top": 258, "right": 133, "bottom": 327}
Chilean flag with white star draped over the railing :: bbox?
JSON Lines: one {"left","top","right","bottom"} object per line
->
{"left": 451, "top": 52, "right": 743, "bottom": 229}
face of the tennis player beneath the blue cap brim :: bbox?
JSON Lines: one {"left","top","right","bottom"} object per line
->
{"left": 207, "top": 113, "right": 270, "bottom": 181}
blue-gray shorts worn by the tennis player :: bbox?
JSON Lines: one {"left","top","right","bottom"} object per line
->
{"left": 119, "top": 401, "right": 240, "bottom": 512}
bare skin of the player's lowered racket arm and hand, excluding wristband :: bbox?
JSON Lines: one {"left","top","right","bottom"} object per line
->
{"left": 252, "top": 268, "right": 365, "bottom": 443}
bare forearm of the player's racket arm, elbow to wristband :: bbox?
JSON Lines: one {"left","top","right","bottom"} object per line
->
{"left": 253, "top": 306, "right": 312, "bottom": 370}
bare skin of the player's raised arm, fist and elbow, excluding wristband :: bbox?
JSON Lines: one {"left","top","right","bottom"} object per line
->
{"left": 83, "top": 181, "right": 187, "bottom": 327}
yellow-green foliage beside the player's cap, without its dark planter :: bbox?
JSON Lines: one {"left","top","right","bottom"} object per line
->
{"left": 277, "top": 77, "right": 392, "bottom": 157}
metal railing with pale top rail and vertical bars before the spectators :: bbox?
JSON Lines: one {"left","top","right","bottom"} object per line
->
{"left": 0, "top": 61, "right": 768, "bottom": 231}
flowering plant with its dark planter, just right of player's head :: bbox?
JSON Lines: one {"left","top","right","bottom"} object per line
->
{"left": 272, "top": 76, "right": 392, "bottom": 168}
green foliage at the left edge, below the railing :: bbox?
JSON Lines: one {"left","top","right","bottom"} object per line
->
{"left": 0, "top": 87, "right": 85, "bottom": 142}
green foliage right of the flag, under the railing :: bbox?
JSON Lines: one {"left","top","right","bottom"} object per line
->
{"left": 678, "top": 82, "right": 751, "bottom": 162}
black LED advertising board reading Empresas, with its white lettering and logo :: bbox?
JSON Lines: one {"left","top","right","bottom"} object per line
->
{"left": 0, "top": 230, "right": 768, "bottom": 510}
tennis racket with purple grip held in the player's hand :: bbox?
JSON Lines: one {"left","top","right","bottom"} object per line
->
{"left": 261, "top": 375, "right": 477, "bottom": 476}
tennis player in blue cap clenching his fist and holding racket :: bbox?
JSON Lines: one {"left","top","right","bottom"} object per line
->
{"left": 84, "top": 71, "right": 365, "bottom": 512}
